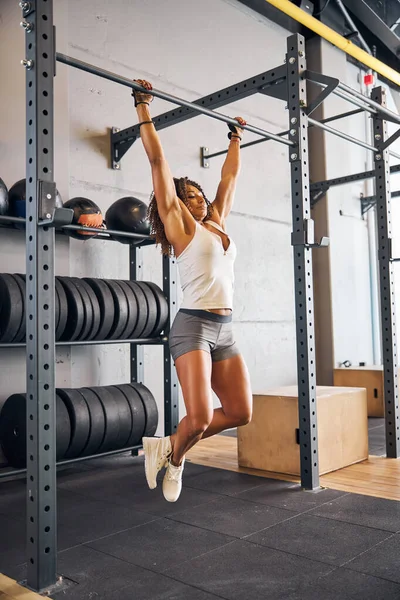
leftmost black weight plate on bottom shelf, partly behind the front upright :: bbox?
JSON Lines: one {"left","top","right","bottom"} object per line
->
{"left": 0, "top": 394, "right": 71, "bottom": 469}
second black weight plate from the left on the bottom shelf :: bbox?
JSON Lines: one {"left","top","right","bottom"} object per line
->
{"left": 56, "top": 388, "right": 90, "bottom": 458}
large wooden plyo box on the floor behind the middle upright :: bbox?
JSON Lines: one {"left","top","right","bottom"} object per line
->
{"left": 238, "top": 386, "right": 368, "bottom": 475}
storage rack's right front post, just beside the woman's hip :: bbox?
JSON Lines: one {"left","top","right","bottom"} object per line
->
{"left": 163, "top": 256, "right": 179, "bottom": 435}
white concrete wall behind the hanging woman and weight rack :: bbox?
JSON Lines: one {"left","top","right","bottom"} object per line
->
{"left": 65, "top": 0, "right": 296, "bottom": 428}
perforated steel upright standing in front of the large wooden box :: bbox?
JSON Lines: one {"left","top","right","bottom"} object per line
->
{"left": 286, "top": 34, "right": 319, "bottom": 489}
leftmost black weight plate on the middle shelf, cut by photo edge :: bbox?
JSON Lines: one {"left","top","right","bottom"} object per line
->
{"left": 0, "top": 273, "right": 22, "bottom": 343}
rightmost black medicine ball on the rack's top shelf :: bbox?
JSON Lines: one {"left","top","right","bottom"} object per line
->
{"left": 106, "top": 196, "right": 150, "bottom": 244}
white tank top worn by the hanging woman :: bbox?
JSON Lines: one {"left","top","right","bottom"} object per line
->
{"left": 177, "top": 221, "right": 237, "bottom": 310}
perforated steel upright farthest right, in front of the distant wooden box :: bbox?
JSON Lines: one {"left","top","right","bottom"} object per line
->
{"left": 371, "top": 87, "right": 400, "bottom": 458}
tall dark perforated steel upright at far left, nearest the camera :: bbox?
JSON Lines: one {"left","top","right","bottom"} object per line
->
{"left": 21, "top": 0, "right": 57, "bottom": 591}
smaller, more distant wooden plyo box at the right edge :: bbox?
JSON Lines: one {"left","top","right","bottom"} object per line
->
{"left": 333, "top": 365, "right": 394, "bottom": 417}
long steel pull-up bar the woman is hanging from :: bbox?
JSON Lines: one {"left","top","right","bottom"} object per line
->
{"left": 56, "top": 52, "right": 294, "bottom": 146}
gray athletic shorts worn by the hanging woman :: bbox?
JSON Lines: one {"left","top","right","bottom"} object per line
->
{"left": 169, "top": 308, "right": 239, "bottom": 362}
